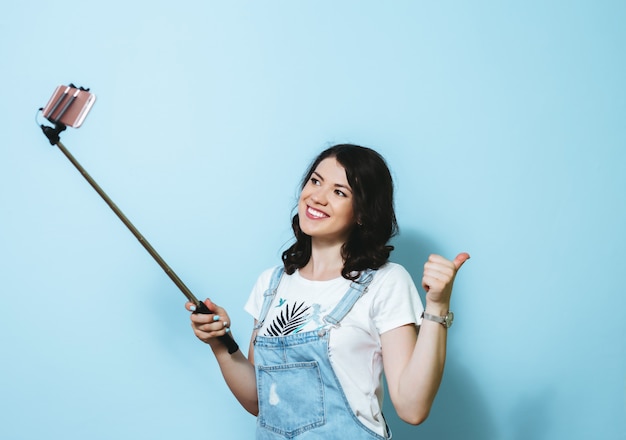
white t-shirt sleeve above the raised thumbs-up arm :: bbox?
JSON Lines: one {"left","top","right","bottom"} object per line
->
{"left": 370, "top": 264, "right": 424, "bottom": 334}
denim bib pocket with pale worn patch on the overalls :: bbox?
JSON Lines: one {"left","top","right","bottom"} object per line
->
{"left": 257, "top": 362, "right": 326, "bottom": 438}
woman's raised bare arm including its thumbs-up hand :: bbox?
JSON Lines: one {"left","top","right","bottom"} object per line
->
{"left": 381, "top": 253, "right": 469, "bottom": 425}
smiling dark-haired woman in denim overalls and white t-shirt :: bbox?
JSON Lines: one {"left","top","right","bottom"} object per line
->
{"left": 187, "top": 144, "right": 469, "bottom": 439}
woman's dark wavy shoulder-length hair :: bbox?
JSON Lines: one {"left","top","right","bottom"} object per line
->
{"left": 282, "top": 144, "right": 398, "bottom": 281}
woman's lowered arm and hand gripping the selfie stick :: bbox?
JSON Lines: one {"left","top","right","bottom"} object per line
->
{"left": 186, "top": 299, "right": 259, "bottom": 416}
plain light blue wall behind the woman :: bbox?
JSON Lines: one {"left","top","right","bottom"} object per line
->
{"left": 0, "top": 0, "right": 626, "bottom": 440}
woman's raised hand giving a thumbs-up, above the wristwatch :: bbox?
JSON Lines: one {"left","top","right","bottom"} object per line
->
{"left": 422, "top": 252, "right": 470, "bottom": 308}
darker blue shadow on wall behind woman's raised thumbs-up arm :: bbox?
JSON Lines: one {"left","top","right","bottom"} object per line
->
{"left": 384, "top": 229, "right": 496, "bottom": 440}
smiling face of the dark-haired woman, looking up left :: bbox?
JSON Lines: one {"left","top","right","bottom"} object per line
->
{"left": 298, "top": 157, "right": 356, "bottom": 248}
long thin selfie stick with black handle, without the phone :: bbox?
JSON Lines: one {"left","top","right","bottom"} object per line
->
{"left": 41, "top": 116, "right": 239, "bottom": 354}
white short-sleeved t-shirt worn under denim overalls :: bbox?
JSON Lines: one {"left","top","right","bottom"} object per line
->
{"left": 245, "top": 263, "right": 424, "bottom": 436}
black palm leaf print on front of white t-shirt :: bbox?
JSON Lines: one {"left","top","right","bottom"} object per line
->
{"left": 265, "top": 298, "right": 321, "bottom": 336}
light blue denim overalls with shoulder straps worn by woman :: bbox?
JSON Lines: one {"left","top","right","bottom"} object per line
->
{"left": 254, "top": 266, "right": 391, "bottom": 440}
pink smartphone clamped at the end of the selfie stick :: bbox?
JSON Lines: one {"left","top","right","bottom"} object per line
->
{"left": 43, "top": 85, "right": 96, "bottom": 128}
